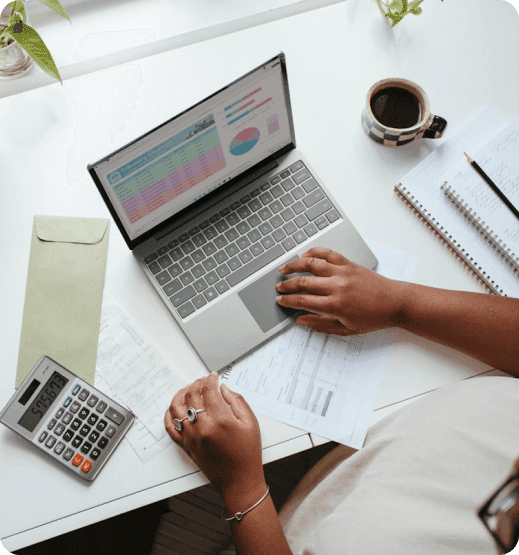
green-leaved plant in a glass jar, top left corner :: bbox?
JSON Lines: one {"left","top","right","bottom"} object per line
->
{"left": 0, "top": 0, "right": 70, "bottom": 81}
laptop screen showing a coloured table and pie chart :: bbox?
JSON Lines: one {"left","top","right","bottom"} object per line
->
{"left": 88, "top": 54, "right": 295, "bottom": 249}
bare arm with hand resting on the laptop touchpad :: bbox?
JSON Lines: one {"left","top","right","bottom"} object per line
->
{"left": 278, "top": 248, "right": 519, "bottom": 377}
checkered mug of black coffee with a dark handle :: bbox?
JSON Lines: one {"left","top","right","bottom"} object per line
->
{"left": 362, "top": 78, "right": 447, "bottom": 146}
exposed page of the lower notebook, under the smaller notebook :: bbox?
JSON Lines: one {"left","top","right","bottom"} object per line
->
{"left": 401, "top": 108, "right": 519, "bottom": 297}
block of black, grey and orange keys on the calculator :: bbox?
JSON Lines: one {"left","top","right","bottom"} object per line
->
{"left": 37, "top": 384, "right": 130, "bottom": 482}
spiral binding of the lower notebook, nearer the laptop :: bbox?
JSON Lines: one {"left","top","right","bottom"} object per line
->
{"left": 395, "top": 183, "right": 506, "bottom": 296}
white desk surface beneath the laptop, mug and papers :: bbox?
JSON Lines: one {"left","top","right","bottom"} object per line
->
{"left": 0, "top": 0, "right": 519, "bottom": 550}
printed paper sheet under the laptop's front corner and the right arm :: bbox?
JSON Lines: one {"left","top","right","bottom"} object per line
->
{"left": 220, "top": 244, "right": 417, "bottom": 449}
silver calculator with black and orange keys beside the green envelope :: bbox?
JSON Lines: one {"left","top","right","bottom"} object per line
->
{"left": 0, "top": 356, "right": 135, "bottom": 482}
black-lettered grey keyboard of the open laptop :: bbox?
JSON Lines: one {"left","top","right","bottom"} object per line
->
{"left": 144, "top": 161, "right": 341, "bottom": 318}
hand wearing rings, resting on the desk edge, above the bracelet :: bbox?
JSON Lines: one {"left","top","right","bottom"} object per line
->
{"left": 164, "top": 374, "right": 266, "bottom": 497}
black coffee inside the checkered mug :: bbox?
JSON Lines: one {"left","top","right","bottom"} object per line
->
{"left": 371, "top": 87, "right": 421, "bottom": 129}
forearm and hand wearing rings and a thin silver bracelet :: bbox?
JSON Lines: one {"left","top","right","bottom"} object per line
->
{"left": 164, "top": 374, "right": 292, "bottom": 555}
